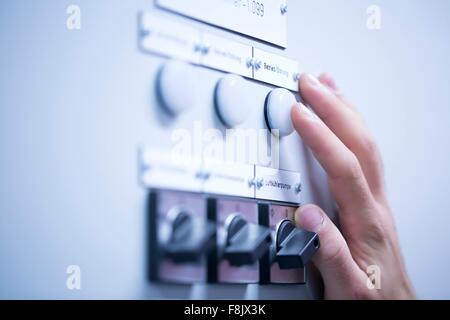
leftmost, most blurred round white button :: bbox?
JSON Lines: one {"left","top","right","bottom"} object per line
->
{"left": 157, "top": 60, "right": 197, "bottom": 116}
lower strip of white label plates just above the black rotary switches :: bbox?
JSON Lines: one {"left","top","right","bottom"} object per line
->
{"left": 139, "top": 147, "right": 301, "bottom": 203}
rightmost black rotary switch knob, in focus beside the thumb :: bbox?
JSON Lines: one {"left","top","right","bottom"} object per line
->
{"left": 276, "top": 220, "right": 320, "bottom": 269}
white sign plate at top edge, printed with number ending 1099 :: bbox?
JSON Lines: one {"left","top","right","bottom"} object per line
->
{"left": 157, "top": 0, "right": 287, "bottom": 48}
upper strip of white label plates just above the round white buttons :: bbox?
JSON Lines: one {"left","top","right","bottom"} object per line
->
{"left": 138, "top": 12, "right": 299, "bottom": 91}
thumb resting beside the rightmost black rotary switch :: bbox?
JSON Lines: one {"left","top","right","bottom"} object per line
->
{"left": 295, "top": 204, "right": 367, "bottom": 299}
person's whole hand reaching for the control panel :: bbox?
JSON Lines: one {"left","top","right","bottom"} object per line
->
{"left": 291, "top": 74, "right": 415, "bottom": 299}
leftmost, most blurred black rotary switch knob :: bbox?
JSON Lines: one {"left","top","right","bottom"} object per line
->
{"left": 164, "top": 211, "right": 216, "bottom": 263}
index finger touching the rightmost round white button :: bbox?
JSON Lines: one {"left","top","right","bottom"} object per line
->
{"left": 291, "top": 103, "right": 374, "bottom": 216}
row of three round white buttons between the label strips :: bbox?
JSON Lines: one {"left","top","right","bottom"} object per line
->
{"left": 157, "top": 60, "right": 296, "bottom": 137}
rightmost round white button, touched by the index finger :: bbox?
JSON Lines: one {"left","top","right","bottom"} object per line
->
{"left": 265, "top": 88, "right": 297, "bottom": 137}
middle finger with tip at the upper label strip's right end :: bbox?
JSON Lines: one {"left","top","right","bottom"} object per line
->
{"left": 299, "top": 74, "right": 384, "bottom": 197}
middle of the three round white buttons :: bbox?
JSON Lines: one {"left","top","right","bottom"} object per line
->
{"left": 214, "top": 74, "right": 251, "bottom": 128}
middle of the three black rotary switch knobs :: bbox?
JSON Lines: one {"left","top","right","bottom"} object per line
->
{"left": 223, "top": 215, "right": 272, "bottom": 266}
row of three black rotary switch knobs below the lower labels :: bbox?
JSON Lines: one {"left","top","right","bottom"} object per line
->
{"left": 167, "top": 211, "right": 319, "bottom": 269}
